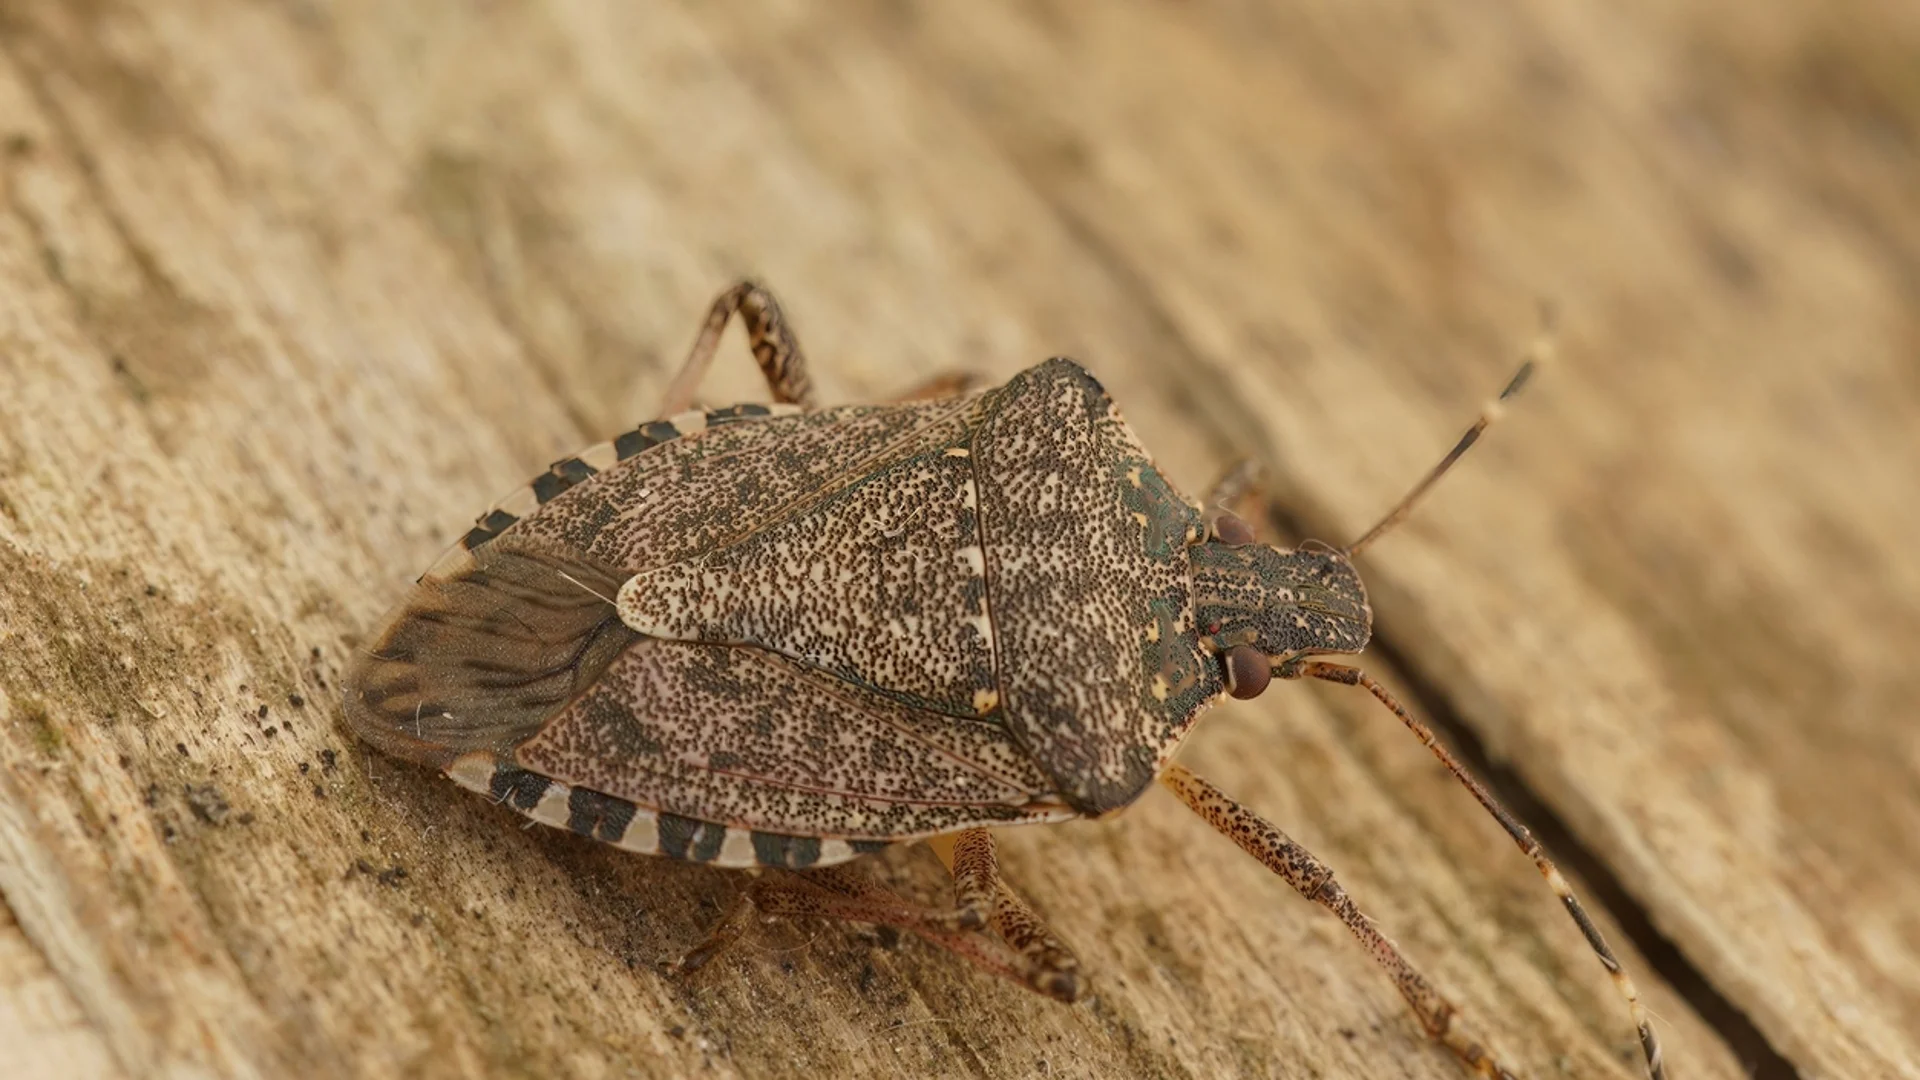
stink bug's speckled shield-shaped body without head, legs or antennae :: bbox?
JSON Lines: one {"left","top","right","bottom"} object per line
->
{"left": 348, "top": 359, "right": 1223, "bottom": 867}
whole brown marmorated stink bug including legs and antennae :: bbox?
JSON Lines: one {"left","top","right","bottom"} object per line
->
{"left": 346, "top": 282, "right": 1663, "bottom": 1080}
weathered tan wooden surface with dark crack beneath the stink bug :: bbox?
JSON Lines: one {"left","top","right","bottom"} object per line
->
{"left": 0, "top": 0, "right": 1920, "bottom": 1080}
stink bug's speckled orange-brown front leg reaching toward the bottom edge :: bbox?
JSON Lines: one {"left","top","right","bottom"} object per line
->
{"left": 1160, "top": 763, "right": 1513, "bottom": 1080}
